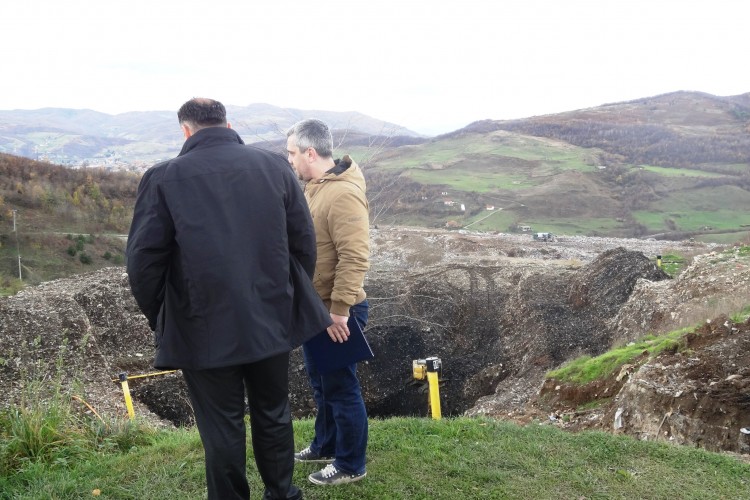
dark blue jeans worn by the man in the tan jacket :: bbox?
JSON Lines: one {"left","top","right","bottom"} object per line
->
{"left": 302, "top": 300, "right": 369, "bottom": 474}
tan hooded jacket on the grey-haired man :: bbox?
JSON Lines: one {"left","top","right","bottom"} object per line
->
{"left": 305, "top": 155, "right": 370, "bottom": 316}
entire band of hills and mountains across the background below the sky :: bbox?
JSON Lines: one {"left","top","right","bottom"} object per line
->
{"left": 0, "top": 92, "right": 750, "bottom": 293}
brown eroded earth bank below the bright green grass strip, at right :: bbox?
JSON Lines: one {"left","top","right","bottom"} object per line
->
{"left": 536, "top": 317, "right": 750, "bottom": 454}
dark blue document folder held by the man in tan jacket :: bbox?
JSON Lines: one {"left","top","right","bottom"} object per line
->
{"left": 305, "top": 316, "right": 375, "bottom": 373}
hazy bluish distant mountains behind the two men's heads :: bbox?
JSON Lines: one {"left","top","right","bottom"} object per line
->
{"left": 0, "top": 104, "right": 419, "bottom": 165}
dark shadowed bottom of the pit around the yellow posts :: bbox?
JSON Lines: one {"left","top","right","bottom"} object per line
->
{"left": 130, "top": 326, "right": 490, "bottom": 427}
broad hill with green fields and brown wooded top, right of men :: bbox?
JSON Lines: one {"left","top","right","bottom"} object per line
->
{"left": 367, "top": 92, "right": 750, "bottom": 242}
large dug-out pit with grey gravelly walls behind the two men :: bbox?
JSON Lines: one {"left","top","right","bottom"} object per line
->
{"left": 125, "top": 249, "right": 667, "bottom": 425}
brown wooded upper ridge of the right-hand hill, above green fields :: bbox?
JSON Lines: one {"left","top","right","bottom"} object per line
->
{"left": 446, "top": 91, "right": 750, "bottom": 167}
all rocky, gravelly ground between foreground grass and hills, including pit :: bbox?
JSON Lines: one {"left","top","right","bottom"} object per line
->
{"left": 0, "top": 228, "right": 750, "bottom": 453}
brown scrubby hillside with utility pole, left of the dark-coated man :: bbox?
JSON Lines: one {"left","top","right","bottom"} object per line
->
{"left": 0, "top": 153, "right": 140, "bottom": 293}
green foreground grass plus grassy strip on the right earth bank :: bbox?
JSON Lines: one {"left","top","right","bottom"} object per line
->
{"left": 0, "top": 306, "right": 750, "bottom": 500}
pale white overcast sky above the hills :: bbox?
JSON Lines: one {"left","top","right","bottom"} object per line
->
{"left": 0, "top": 0, "right": 750, "bottom": 134}
